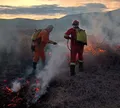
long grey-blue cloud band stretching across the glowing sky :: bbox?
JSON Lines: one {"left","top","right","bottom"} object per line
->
{"left": 0, "top": 3, "right": 106, "bottom": 15}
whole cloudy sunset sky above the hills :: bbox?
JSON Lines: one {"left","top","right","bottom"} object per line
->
{"left": 0, "top": 0, "right": 120, "bottom": 20}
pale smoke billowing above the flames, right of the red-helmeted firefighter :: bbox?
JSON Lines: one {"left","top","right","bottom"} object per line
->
{"left": 79, "top": 11, "right": 120, "bottom": 45}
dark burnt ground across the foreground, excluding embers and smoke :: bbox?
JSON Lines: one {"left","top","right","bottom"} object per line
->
{"left": 0, "top": 48, "right": 120, "bottom": 108}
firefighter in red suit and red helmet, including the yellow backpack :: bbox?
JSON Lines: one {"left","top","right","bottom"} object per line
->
{"left": 64, "top": 20, "right": 87, "bottom": 76}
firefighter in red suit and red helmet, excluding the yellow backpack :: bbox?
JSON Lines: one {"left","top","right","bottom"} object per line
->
{"left": 64, "top": 20, "right": 87, "bottom": 76}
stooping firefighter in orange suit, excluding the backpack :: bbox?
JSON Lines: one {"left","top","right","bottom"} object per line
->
{"left": 33, "top": 25, "right": 57, "bottom": 70}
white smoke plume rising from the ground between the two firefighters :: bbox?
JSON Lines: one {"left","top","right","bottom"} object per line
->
{"left": 29, "top": 44, "right": 68, "bottom": 102}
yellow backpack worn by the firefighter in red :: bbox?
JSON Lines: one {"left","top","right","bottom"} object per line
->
{"left": 76, "top": 29, "right": 87, "bottom": 45}
